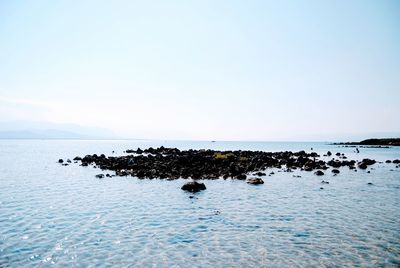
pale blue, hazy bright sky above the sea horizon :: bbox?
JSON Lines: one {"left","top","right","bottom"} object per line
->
{"left": 0, "top": 0, "right": 400, "bottom": 141}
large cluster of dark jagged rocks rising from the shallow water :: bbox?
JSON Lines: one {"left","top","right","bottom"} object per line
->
{"left": 69, "top": 147, "right": 382, "bottom": 180}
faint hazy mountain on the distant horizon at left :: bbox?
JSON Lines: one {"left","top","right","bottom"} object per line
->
{"left": 0, "top": 121, "right": 117, "bottom": 139}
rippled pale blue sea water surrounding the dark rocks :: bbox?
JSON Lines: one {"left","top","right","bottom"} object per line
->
{"left": 0, "top": 140, "right": 400, "bottom": 267}
